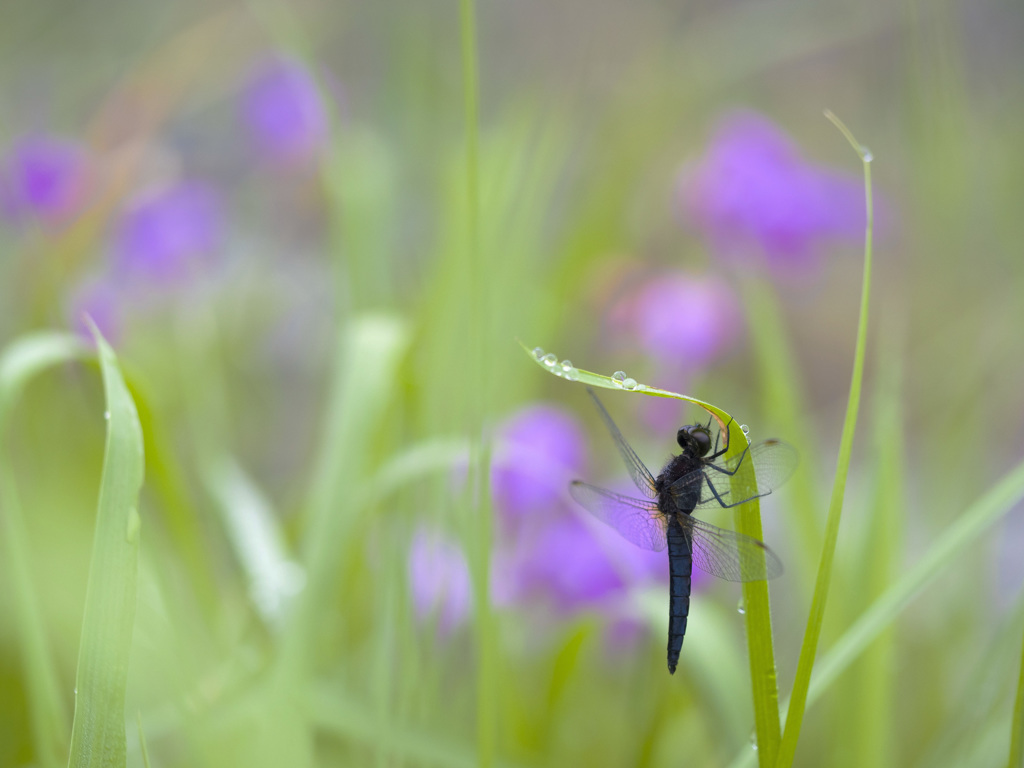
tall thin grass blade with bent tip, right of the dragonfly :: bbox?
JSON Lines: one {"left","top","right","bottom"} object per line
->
{"left": 775, "top": 113, "right": 873, "bottom": 768}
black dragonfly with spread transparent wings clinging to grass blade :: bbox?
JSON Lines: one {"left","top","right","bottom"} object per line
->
{"left": 569, "top": 387, "right": 797, "bottom": 674}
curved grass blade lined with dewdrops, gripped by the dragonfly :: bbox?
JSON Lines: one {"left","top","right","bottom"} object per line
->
{"left": 519, "top": 342, "right": 781, "bottom": 768}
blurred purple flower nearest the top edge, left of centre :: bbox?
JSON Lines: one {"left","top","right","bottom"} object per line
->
{"left": 241, "top": 55, "right": 329, "bottom": 165}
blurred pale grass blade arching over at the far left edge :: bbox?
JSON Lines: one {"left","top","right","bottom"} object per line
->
{"left": 0, "top": 333, "right": 89, "bottom": 766}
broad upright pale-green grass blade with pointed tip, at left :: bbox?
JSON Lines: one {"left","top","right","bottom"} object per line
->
{"left": 68, "top": 329, "right": 143, "bottom": 768}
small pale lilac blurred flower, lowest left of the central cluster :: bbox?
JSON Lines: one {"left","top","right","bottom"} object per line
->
{"left": 409, "top": 526, "right": 473, "bottom": 635}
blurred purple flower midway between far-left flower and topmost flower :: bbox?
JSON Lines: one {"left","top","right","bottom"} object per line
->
{"left": 113, "top": 181, "right": 224, "bottom": 285}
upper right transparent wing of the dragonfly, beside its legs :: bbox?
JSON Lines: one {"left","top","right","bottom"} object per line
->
{"left": 669, "top": 438, "right": 799, "bottom": 509}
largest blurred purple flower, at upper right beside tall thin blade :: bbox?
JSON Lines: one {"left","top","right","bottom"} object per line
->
{"left": 679, "top": 112, "right": 865, "bottom": 271}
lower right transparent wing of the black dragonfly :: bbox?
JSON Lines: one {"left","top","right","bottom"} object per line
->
{"left": 678, "top": 515, "right": 782, "bottom": 582}
